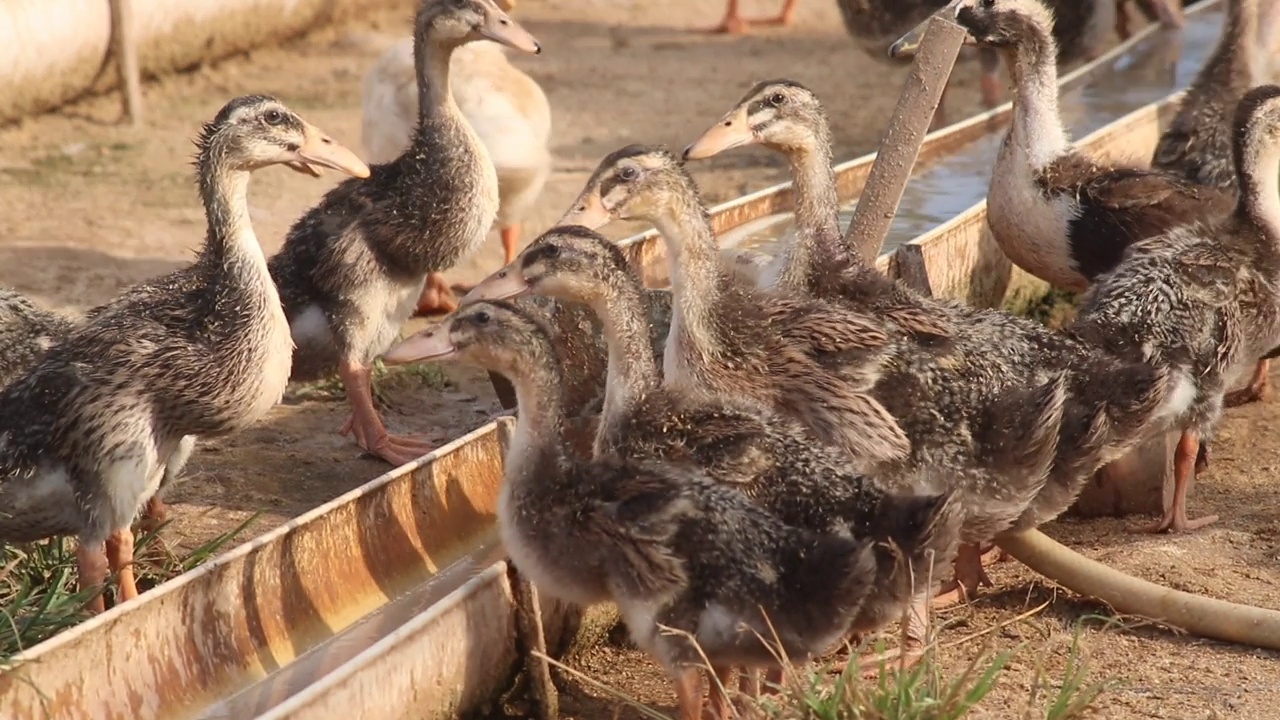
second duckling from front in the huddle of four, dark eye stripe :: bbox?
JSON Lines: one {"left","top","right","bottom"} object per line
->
{"left": 463, "top": 227, "right": 962, "bottom": 666}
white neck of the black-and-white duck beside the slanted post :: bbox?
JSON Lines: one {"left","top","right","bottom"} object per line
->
{"left": 1005, "top": 33, "right": 1069, "bottom": 169}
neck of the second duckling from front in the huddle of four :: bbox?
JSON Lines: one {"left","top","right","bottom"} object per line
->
{"left": 591, "top": 272, "right": 660, "bottom": 425}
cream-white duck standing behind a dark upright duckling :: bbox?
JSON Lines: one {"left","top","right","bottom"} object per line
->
{"left": 361, "top": 0, "right": 552, "bottom": 313}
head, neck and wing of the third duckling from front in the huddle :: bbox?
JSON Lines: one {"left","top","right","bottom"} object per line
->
{"left": 561, "top": 145, "right": 910, "bottom": 464}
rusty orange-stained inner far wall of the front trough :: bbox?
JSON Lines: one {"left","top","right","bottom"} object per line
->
{"left": 0, "top": 423, "right": 504, "bottom": 719}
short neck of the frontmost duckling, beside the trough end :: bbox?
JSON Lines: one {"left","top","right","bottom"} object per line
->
{"left": 507, "top": 355, "right": 564, "bottom": 474}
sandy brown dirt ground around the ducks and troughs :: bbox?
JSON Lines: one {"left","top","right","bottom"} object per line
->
{"left": 0, "top": 0, "right": 1280, "bottom": 720}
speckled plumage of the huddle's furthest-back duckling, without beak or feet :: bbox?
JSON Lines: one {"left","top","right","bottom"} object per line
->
{"left": 680, "top": 81, "right": 1164, "bottom": 542}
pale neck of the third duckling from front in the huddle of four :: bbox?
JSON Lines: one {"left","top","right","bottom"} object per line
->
{"left": 653, "top": 190, "right": 721, "bottom": 356}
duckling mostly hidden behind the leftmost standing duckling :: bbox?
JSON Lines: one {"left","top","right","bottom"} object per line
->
{"left": 0, "top": 288, "right": 196, "bottom": 529}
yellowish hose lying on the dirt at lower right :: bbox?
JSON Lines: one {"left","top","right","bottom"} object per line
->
{"left": 997, "top": 530, "right": 1280, "bottom": 650}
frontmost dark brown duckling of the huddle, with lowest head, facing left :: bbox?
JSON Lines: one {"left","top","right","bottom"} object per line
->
{"left": 383, "top": 297, "right": 874, "bottom": 720}
